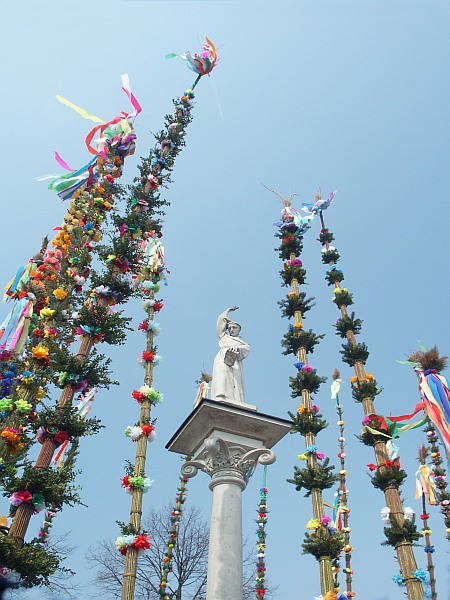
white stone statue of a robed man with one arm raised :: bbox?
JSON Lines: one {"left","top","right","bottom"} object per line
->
{"left": 211, "top": 306, "right": 250, "bottom": 403}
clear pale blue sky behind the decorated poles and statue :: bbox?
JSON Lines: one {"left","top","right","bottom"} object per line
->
{"left": 0, "top": 0, "right": 450, "bottom": 600}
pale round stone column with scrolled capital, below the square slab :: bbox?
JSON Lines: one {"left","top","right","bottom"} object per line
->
{"left": 181, "top": 434, "right": 275, "bottom": 600}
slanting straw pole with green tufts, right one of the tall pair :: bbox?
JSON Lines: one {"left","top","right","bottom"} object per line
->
{"left": 314, "top": 203, "right": 424, "bottom": 600}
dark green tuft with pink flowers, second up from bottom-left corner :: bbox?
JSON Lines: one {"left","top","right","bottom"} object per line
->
{"left": 3, "top": 463, "right": 81, "bottom": 508}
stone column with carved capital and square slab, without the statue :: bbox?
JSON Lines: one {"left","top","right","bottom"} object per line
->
{"left": 166, "top": 400, "right": 291, "bottom": 600}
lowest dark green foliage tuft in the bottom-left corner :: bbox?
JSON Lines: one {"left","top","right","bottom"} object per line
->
{"left": 0, "top": 536, "right": 62, "bottom": 587}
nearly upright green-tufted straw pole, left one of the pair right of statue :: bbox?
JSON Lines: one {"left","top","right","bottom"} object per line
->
{"left": 276, "top": 191, "right": 344, "bottom": 599}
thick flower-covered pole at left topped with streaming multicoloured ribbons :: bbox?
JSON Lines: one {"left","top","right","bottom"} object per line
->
{"left": 3, "top": 77, "right": 140, "bottom": 546}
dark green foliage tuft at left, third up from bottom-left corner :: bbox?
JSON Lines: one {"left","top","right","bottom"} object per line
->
{"left": 31, "top": 404, "right": 103, "bottom": 440}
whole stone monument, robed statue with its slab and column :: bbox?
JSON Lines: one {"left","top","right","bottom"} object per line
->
{"left": 166, "top": 307, "right": 292, "bottom": 600}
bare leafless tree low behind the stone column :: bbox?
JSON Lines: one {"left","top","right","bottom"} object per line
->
{"left": 87, "top": 505, "right": 273, "bottom": 600}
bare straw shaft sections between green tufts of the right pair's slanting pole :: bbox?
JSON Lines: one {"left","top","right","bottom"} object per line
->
{"left": 321, "top": 220, "right": 423, "bottom": 600}
